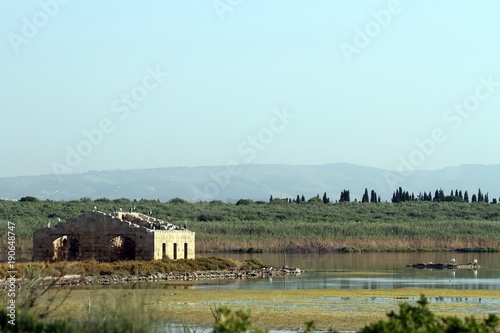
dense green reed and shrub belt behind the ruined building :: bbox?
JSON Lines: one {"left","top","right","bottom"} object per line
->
{"left": 0, "top": 195, "right": 500, "bottom": 251}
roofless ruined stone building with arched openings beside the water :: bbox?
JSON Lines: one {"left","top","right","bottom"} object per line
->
{"left": 33, "top": 211, "right": 195, "bottom": 261}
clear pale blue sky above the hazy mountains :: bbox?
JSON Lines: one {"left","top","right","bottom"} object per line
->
{"left": 0, "top": 0, "right": 500, "bottom": 177}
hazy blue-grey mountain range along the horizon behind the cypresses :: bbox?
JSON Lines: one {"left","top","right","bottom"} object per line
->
{"left": 0, "top": 163, "right": 500, "bottom": 202}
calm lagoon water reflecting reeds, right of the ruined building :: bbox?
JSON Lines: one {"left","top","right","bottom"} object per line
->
{"left": 195, "top": 252, "right": 500, "bottom": 289}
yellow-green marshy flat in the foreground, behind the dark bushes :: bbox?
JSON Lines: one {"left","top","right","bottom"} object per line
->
{"left": 30, "top": 284, "right": 500, "bottom": 330}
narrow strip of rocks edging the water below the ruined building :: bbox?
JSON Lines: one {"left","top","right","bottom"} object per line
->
{"left": 1, "top": 266, "right": 304, "bottom": 287}
